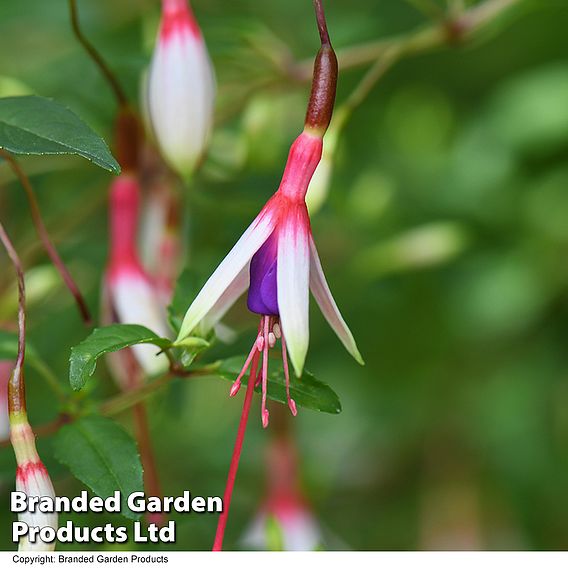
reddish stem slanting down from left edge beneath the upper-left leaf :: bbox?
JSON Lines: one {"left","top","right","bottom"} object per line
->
{"left": 0, "top": 149, "right": 92, "bottom": 325}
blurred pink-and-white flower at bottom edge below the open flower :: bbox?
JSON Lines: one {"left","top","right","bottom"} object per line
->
{"left": 243, "top": 437, "right": 323, "bottom": 550}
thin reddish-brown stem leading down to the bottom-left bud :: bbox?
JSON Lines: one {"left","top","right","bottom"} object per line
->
{"left": 0, "top": 223, "right": 26, "bottom": 417}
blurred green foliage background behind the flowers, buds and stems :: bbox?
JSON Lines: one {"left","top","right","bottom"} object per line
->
{"left": 0, "top": 0, "right": 568, "bottom": 550}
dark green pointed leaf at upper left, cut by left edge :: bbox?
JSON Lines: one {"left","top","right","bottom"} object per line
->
{"left": 0, "top": 96, "right": 120, "bottom": 174}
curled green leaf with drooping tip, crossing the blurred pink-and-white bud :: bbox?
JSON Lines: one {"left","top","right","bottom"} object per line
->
{"left": 69, "top": 324, "right": 171, "bottom": 390}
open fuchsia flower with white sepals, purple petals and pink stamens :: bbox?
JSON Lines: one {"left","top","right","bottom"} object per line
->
{"left": 177, "top": 38, "right": 363, "bottom": 427}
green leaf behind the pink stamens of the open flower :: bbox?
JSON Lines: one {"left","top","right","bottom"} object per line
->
{"left": 212, "top": 356, "right": 341, "bottom": 414}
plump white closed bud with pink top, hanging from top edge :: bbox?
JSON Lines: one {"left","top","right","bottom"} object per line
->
{"left": 147, "top": 0, "right": 215, "bottom": 176}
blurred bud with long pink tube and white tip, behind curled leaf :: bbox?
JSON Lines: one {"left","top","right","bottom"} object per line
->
{"left": 104, "top": 174, "right": 168, "bottom": 375}
